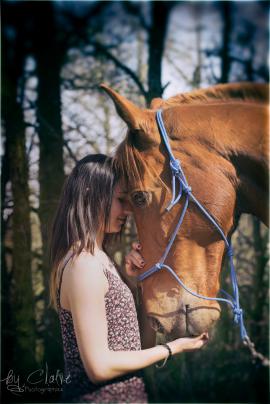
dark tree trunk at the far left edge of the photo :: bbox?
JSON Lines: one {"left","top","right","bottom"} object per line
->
{"left": 2, "top": 3, "right": 35, "bottom": 375}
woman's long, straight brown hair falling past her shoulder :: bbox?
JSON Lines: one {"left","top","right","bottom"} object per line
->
{"left": 50, "top": 154, "right": 120, "bottom": 308}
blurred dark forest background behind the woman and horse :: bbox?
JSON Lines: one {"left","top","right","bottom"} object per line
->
{"left": 1, "top": 1, "right": 269, "bottom": 403}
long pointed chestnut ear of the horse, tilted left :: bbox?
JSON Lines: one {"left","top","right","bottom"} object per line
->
{"left": 100, "top": 83, "right": 154, "bottom": 135}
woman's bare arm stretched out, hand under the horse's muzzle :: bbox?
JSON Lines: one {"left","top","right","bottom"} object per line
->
{"left": 66, "top": 254, "right": 209, "bottom": 383}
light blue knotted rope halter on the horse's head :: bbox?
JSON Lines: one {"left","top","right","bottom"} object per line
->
{"left": 137, "top": 110, "right": 249, "bottom": 341}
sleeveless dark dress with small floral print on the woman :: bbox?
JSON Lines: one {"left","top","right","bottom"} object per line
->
{"left": 57, "top": 251, "right": 148, "bottom": 403}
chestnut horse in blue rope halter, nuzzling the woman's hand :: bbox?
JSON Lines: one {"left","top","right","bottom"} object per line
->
{"left": 101, "top": 83, "right": 268, "bottom": 338}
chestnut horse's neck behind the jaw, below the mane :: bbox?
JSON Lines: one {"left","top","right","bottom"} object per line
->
{"left": 171, "top": 101, "right": 269, "bottom": 224}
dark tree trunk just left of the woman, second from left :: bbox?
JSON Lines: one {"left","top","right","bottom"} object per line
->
{"left": 32, "top": 2, "right": 64, "bottom": 368}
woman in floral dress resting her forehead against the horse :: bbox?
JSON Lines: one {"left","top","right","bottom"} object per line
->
{"left": 51, "top": 154, "right": 208, "bottom": 403}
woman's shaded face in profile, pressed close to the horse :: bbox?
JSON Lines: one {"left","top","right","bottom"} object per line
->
{"left": 106, "top": 182, "right": 131, "bottom": 233}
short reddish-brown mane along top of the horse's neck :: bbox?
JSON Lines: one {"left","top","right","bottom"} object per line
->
{"left": 151, "top": 82, "right": 269, "bottom": 109}
